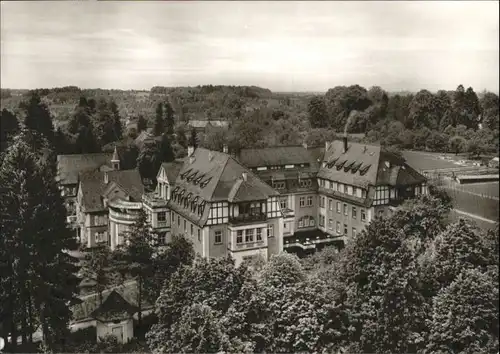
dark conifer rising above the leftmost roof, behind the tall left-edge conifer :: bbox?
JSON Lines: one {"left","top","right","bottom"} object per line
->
{"left": 19, "top": 92, "right": 54, "bottom": 149}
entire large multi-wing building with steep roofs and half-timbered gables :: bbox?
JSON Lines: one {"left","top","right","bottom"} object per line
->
{"left": 58, "top": 138, "right": 427, "bottom": 264}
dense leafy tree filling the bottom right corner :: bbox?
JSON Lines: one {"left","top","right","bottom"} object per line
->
{"left": 427, "top": 269, "right": 499, "bottom": 353}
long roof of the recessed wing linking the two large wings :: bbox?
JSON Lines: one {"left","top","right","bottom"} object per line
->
{"left": 238, "top": 145, "right": 323, "bottom": 169}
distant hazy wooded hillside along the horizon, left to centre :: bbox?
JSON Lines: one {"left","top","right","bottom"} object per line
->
{"left": 0, "top": 85, "right": 307, "bottom": 123}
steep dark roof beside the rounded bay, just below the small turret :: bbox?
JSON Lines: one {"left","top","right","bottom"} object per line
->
{"left": 80, "top": 170, "right": 144, "bottom": 212}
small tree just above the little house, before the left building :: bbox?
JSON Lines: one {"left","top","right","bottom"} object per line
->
{"left": 82, "top": 246, "right": 112, "bottom": 305}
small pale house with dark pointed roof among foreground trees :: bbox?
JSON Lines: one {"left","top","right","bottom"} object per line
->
{"left": 90, "top": 290, "right": 139, "bottom": 343}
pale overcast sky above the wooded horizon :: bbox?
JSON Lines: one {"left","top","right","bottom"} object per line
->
{"left": 0, "top": 1, "right": 499, "bottom": 92}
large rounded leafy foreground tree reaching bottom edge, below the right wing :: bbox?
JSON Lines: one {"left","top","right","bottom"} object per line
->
{"left": 334, "top": 218, "right": 426, "bottom": 353}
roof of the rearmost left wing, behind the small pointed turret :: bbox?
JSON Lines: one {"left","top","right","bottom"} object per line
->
{"left": 57, "top": 153, "right": 113, "bottom": 184}
